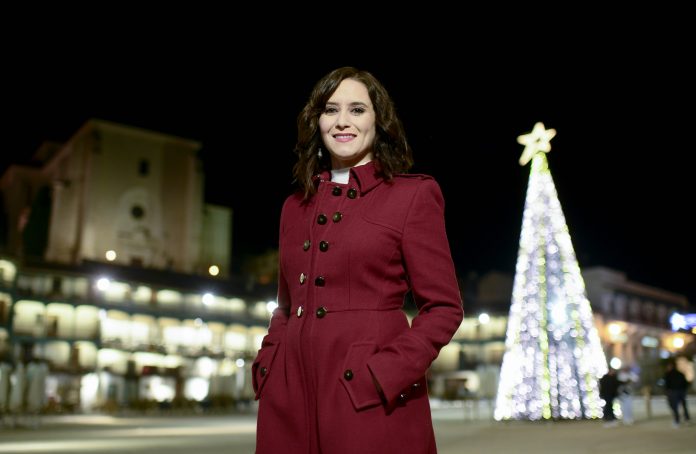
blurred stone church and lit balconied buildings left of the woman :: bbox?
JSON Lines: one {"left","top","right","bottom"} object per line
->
{"left": 0, "top": 120, "right": 275, "bottom": 414}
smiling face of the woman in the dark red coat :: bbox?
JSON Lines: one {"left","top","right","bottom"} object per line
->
{"left": 319, "top": 79, "right": 376, "bottom": 169}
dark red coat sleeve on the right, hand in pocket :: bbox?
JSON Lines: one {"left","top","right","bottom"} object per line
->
{"left": 368, "top": 179, "right": 464, "bottom": 405}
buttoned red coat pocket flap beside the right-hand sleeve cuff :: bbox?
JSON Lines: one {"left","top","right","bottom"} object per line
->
{"left": 339, "top": 342, "right": 382, "bottom": 410}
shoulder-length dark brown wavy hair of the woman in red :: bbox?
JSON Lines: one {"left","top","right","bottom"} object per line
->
{"left": 292, "top": 66, "right": 413, "bottom": 198}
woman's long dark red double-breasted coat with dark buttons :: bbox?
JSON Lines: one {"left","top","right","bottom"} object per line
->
{"left": 252, "top": 163, "right": 463, "bottom": 454}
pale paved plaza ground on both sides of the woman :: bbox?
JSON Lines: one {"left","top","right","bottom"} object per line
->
{"left": 0, "top": 396, "right": 696, "bottom": 454}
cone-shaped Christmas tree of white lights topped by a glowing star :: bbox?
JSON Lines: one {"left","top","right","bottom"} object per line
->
{"left": 495, "top": 123, "right": 607, "bottom": 420}
